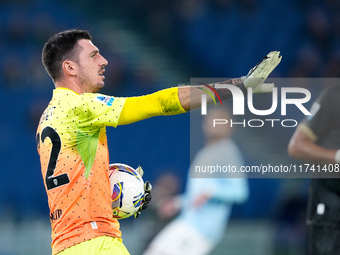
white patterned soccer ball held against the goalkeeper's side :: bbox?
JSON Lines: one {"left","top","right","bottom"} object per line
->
{"left": 109, "top": 163, "right": 144, "bottom": 219}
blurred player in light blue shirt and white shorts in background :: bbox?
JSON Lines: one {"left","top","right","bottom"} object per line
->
{"left": 144, "top": 108, "right": 249, "bottom": 255}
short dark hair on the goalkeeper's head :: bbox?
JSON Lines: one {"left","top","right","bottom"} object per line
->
{"left": 41, "top": 29, "right": 92, "bottom": 81}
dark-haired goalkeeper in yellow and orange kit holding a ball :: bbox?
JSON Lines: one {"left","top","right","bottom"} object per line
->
{"left": 36, "top": 29, "right": 281, "bottom": 255}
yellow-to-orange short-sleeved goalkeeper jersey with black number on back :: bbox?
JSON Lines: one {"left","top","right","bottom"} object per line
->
{"left": 37, "top": 88, "right": 126, "bottom": 254}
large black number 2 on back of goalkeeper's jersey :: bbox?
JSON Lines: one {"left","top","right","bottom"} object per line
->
{"left": 37, "top": 127, "right": 70, "bottom": 190}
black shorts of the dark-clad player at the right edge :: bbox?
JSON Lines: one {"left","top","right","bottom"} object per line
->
{"left": 308, "top": 225, "right": 340, "bottom": 255}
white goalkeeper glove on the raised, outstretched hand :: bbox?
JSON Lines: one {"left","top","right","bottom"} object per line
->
{"left": 242, "top": 51, "right": 282, "bottom": 93}
